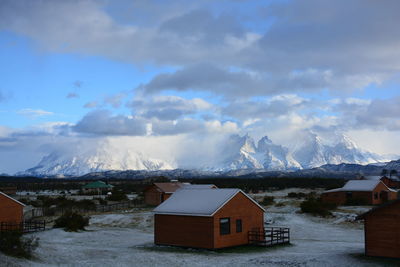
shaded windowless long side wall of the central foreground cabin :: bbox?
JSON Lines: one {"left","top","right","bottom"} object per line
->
{"left": 154, "top": 214, "right": 214, "bottom": 249}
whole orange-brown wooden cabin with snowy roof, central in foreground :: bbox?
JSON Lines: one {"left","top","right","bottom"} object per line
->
{"left": 154, "top": 189, "right": 265, "bottom": 249}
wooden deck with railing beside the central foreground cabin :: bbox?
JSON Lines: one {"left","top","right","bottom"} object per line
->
{"left": 248, "top": 227, "right": 290, "bottom": 247}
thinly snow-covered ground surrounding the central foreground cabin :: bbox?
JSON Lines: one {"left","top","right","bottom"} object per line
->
{"left": 0, "top": 189, "right": 400, "bottom": 266}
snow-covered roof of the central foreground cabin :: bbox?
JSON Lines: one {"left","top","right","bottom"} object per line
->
{"left": 153, "top": 188, "right": 264, "bottom": 216}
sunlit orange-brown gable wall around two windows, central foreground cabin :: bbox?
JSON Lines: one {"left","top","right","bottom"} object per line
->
{"left": 214, "top": 193, "right": 264, "bottom": 248}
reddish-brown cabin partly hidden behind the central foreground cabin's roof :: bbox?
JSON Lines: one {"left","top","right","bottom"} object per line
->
{"left": 144, "top": 181, "right": 217, "bottom": 206}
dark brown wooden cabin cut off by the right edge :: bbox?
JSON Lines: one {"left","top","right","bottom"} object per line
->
{"left": 357, "top": 200, "right": 400, "bottom": 258}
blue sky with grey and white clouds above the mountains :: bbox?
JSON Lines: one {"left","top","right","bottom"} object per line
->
{"left": 0, "top": 0, "right": 400, "bottom": 173}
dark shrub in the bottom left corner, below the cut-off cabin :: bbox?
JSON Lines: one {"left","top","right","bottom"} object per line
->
{"left": 0, "top": 231, "right": 39, "bottom": 259}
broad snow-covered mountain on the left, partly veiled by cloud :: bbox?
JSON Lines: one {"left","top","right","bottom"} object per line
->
{"left": 17, "top": 142, "right": 174, "bottom": 176}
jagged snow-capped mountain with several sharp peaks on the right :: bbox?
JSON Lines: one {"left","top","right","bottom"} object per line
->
{"left": 206, "top": 133, "right": 382, "bottom": 171}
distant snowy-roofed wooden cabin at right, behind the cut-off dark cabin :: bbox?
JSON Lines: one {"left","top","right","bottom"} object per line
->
{"left": 321, "top": 180, "right": 397, "bottom": 205}
